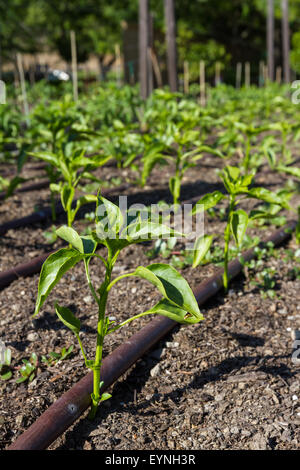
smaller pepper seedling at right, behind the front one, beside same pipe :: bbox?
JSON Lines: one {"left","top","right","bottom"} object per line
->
{"left": 192, "top": 166, "right": 289, "bottom": 292}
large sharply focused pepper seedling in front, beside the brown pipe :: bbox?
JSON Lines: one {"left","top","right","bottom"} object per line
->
{"left": 34, "top": 195, "right": 203, "bottom": 418}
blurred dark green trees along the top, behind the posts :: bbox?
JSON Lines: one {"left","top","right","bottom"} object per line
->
{"left": 0, "top": 0, "right": 300, "bottom": 78}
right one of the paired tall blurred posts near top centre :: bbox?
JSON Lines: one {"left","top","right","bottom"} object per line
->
{"left": 164, "top": 0, "right": 178, "bottom": 92}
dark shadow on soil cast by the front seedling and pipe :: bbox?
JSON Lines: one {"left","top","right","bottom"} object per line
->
{"left": 52, "top": 324, "right": 293, "bottom": 450}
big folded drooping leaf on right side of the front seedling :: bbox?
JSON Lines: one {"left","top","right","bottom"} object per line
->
{"left": 135, "top": 263, "right": 201, "bottom": 319}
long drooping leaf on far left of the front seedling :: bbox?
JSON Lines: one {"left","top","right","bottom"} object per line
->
{"left": 34, "top": 248, "right": 84, "bottom": 315}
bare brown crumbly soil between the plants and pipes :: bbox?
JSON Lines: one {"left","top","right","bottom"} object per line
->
{"left": 0, "top": 153, "right": 300, "bottom": 450}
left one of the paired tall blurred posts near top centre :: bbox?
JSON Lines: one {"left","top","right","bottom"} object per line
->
{"left": 139, "top": 0, "right": 149, "bottom": 100}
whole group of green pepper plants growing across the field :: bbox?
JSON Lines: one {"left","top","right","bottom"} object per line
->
{"left": 0, "top": 79, "right": 300, "bottom": 417}
